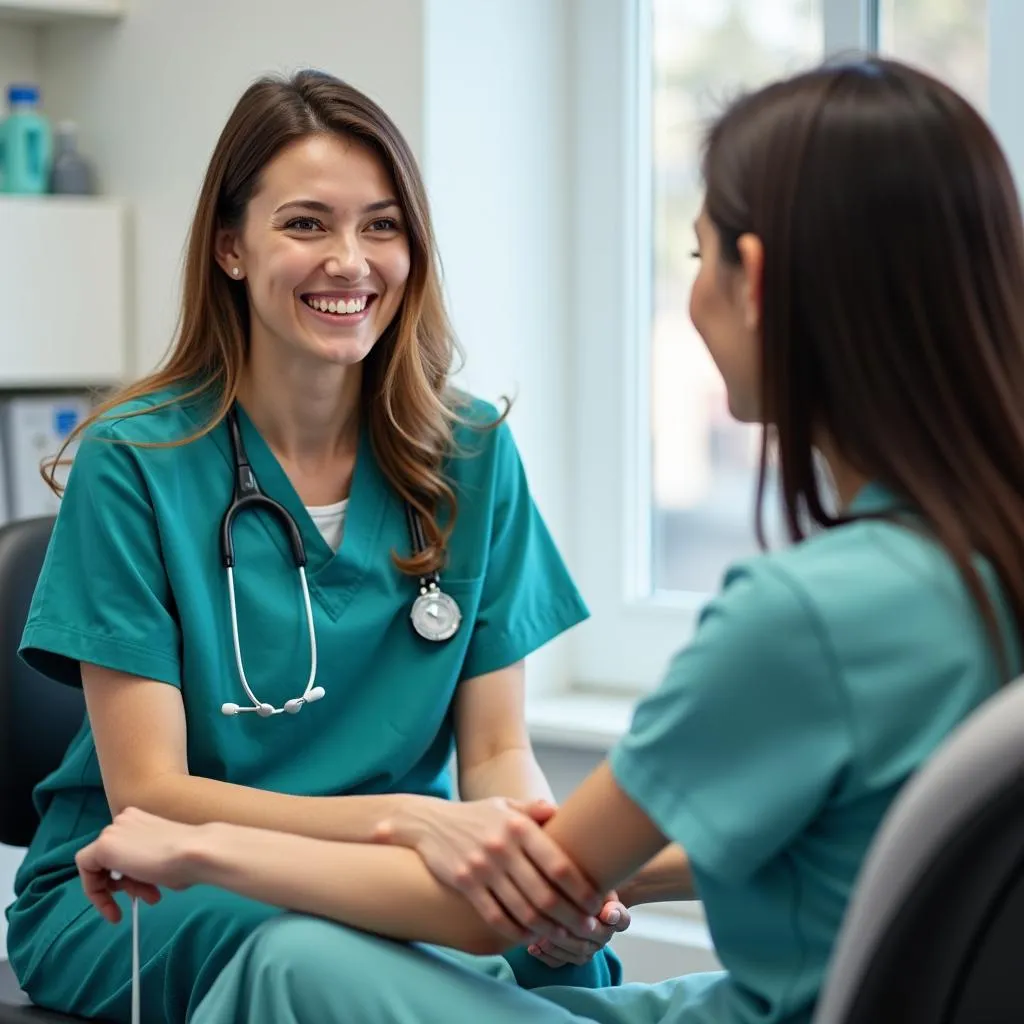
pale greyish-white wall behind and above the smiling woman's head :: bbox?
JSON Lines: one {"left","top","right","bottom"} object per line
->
{"left": 41, "top": 0, "right": 423, "bottom": 373}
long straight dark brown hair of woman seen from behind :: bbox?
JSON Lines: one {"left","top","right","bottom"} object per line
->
{"left": 703, "top": 58, "right": 1024, "bottom": 667}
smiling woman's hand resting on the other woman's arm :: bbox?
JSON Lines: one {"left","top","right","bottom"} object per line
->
{"left": 374, "top": 797, "right": 604, "bottom": 943}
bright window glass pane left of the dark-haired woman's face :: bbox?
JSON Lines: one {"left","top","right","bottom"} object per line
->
{"left": 645, "top": 0, "right": 824, "bottom": 594}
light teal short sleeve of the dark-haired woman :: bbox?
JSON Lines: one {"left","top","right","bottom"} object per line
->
{"left": 610, "top": 559, "right": 851, "bottom": 883}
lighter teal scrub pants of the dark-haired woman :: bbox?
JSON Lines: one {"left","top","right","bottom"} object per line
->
{"left": 191, "top": 914, "right": 722, "bottom": 1024}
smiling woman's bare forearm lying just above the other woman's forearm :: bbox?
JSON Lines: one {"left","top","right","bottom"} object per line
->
{"left": 133, "top": 775, "right": 430, "bottom": 843}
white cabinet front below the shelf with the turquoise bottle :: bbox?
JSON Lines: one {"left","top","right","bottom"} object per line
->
{"left": 0, "top": 196, "right": 128, "bottom": 388}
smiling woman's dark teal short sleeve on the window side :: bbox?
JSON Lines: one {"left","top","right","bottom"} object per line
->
{"left": 462, "top": 423, "right": 588, "bottom": 679}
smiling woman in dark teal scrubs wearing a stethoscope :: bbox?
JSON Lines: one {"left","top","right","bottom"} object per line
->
{"left": 8, "top": 72, "right": 629, "bottom": 1024}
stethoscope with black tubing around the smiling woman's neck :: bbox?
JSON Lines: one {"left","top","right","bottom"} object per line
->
{"left": 220, "top": 406, "right": 462, "bottom": 718}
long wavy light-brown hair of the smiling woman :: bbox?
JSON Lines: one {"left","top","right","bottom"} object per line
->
{"left": 44, "top": 71, "right": 495, "bottom": 574}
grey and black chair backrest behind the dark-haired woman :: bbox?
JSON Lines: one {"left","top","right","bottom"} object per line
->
{"left": 814, "top": 680, "right": 1024, "bottom": 1024}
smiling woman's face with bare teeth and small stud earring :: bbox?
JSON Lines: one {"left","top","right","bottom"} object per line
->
{"left": 216, "top": 134, "right": 411, "bottom": 366}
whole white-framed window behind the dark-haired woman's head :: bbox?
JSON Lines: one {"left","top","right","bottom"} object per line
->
{"left": 572, "top": 0, "right": 1011, "bottom": 690}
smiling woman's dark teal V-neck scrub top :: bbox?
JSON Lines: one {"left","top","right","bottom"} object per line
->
{"left": 15, "top": 392, "right": 587, "bottom": 932}
